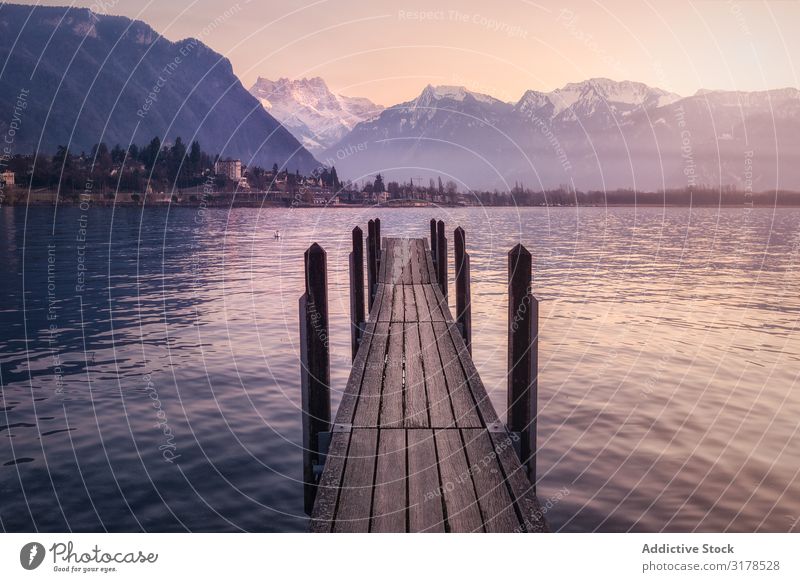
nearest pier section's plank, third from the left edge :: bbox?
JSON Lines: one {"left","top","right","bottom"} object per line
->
{"left": 370, "top": 430, "right": 408, "bottom": 532}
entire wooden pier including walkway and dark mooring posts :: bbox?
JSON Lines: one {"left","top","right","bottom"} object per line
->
{"left": 301, "top": 221, "right": 546, "bottom": 532}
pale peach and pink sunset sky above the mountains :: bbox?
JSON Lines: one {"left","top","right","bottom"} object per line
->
{"left": 34, "top": 0, "right": 800, "bottom": 105}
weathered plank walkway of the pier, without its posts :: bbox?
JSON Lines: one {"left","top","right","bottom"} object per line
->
{"left": 311, "top": 238, "right": 546, "bottom": 532}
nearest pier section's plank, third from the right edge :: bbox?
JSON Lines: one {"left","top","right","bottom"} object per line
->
{"left": 435, "top": 429, "right": 484, "bottom": 533}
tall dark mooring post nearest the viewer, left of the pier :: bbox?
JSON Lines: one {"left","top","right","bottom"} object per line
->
{"left": 300, "top": 243, "right": 331, "bottom": 515}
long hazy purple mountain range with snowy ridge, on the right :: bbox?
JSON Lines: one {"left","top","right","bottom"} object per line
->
{"left": 322, "top": 79, "right": 800, "bottom": 190}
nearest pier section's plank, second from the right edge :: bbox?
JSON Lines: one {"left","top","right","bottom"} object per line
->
{"left": 461, "top": 429, "right": 521, "bottom": 532}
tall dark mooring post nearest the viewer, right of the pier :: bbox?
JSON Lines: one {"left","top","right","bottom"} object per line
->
{"left": 507, "top": 244, "right": 539, "bottom": 488}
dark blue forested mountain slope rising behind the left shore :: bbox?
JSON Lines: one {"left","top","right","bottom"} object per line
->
{"left": 0, "top": 4, "right": 318, "bottom": 172}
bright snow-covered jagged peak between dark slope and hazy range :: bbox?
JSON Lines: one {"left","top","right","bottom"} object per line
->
{"left": 250, "top": 77, "right": 383, "bottom": 151}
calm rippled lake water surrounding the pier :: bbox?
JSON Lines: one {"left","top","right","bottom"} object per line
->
{"left": 0, "top": 208, "right": 800, "bottom": 531}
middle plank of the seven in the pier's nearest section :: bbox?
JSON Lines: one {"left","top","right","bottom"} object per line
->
{"left": 407, "top": 429, "right": 445, "bottom": 532}
